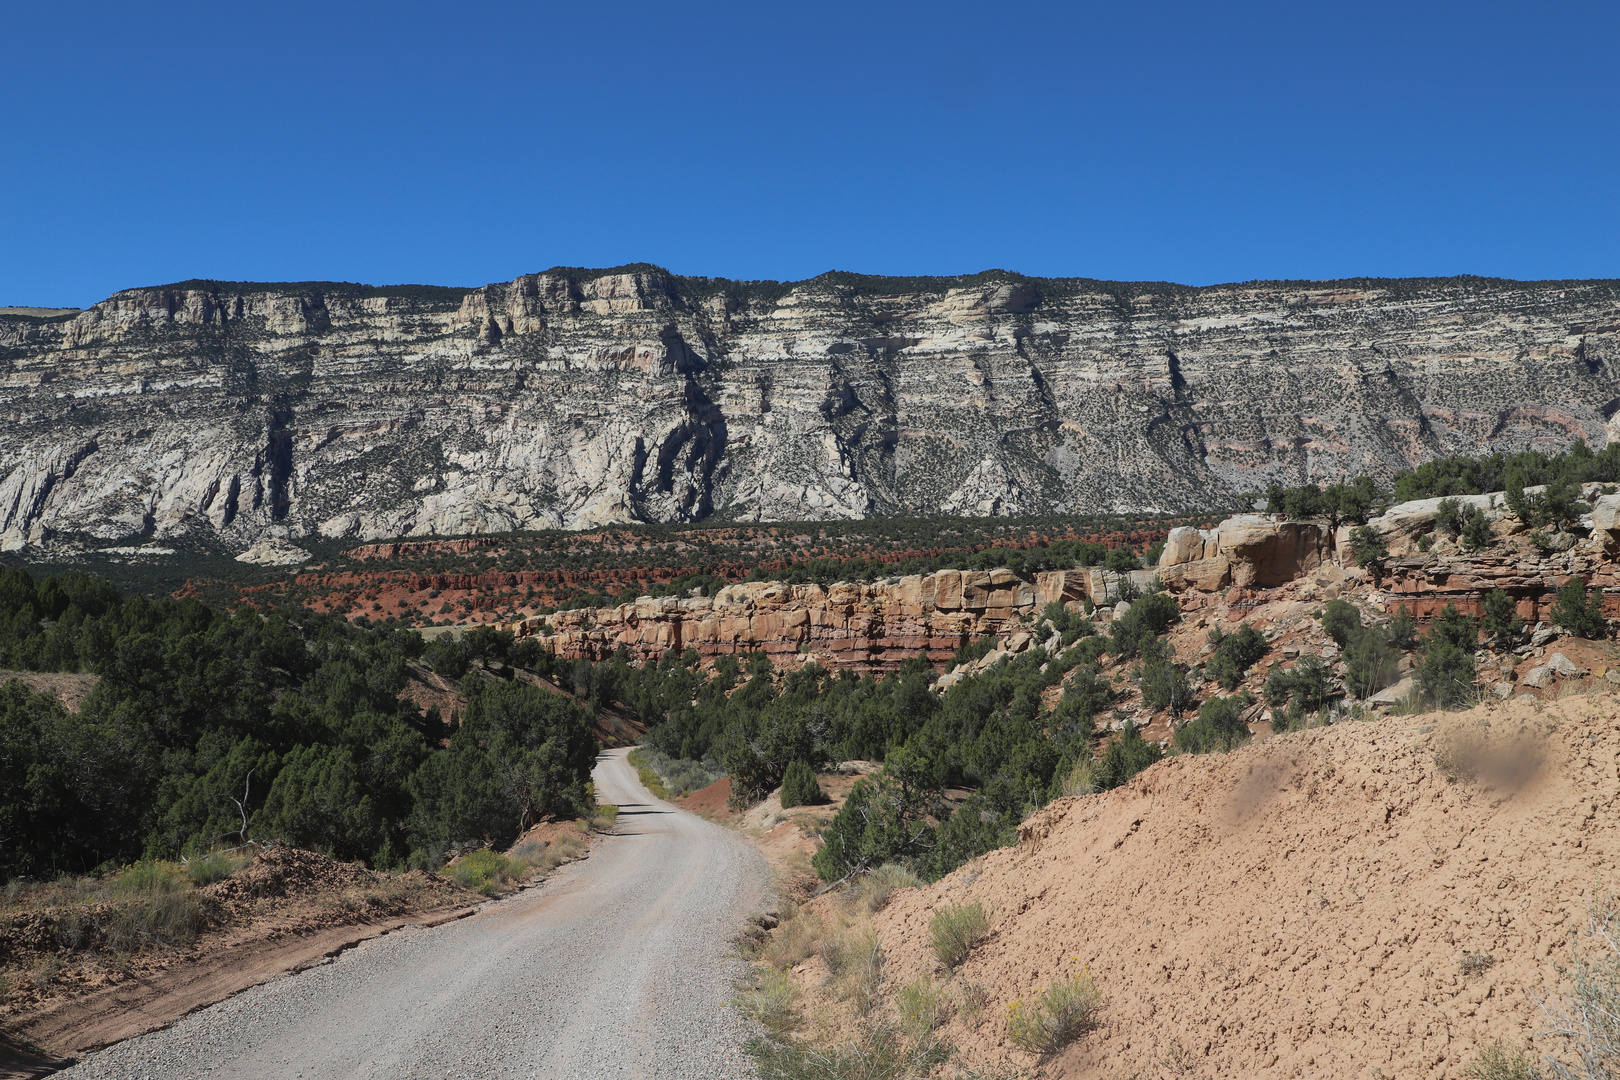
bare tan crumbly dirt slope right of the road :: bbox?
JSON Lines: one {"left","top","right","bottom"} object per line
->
{"left": 795, "top": 693, "right": 1620, "bottom": 1080}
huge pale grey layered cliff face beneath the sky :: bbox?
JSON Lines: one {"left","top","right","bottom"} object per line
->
{"left": 0, "top": 267, "right": 1620, "bottom": 551}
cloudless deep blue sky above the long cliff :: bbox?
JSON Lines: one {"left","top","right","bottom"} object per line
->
{"left": 0, "top": 0, "right": 1620, "bottom": 306}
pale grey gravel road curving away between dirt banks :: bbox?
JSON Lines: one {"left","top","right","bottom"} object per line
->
{"left": 62, "top": 750, "right": 770, "bottom": 1080}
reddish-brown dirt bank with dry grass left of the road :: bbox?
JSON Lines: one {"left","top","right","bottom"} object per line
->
{"left": 0, "top": 847, "right": 483, "bottom": 1078}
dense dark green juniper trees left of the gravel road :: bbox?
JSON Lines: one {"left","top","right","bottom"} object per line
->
{"left": 0, "top": 570, "right": 598, "bottom": 878}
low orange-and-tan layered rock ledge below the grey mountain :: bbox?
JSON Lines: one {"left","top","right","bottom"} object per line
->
{"left": 524, "top": 484, "right": 1620, "bottom": 670}
